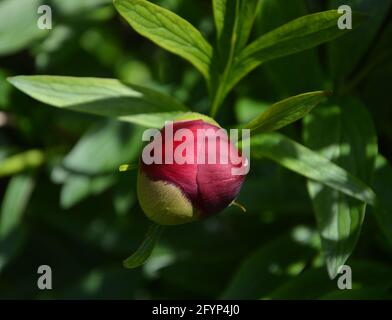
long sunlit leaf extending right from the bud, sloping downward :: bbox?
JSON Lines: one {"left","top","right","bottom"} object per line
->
{"left": 250, "top": 132, "right": 376, "bottom": 205}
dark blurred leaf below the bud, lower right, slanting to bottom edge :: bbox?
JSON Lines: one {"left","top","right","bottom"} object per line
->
{"left": 221, "top": 229, "right": 315, "bottom": 299}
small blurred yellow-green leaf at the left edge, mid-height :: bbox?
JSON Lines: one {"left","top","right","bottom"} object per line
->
{"left": 0, "top": 149, "right": 45, "bottom": 177}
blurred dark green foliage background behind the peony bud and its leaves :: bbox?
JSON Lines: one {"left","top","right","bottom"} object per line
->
{"left": 0, "top": 0, "right": 392, "bottom": 299}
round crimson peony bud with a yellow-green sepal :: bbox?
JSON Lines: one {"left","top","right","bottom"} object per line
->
{"left": 137, "top": 113, "right": 247, "bottom": 225}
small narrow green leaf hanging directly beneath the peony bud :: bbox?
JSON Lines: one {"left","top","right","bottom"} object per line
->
{"left": 123, "top": 223, "right": 164, "bottom": 269}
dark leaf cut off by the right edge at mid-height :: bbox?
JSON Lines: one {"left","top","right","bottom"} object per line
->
{"left": 372, "top": 155, "right": 392, "bottom": 244}
